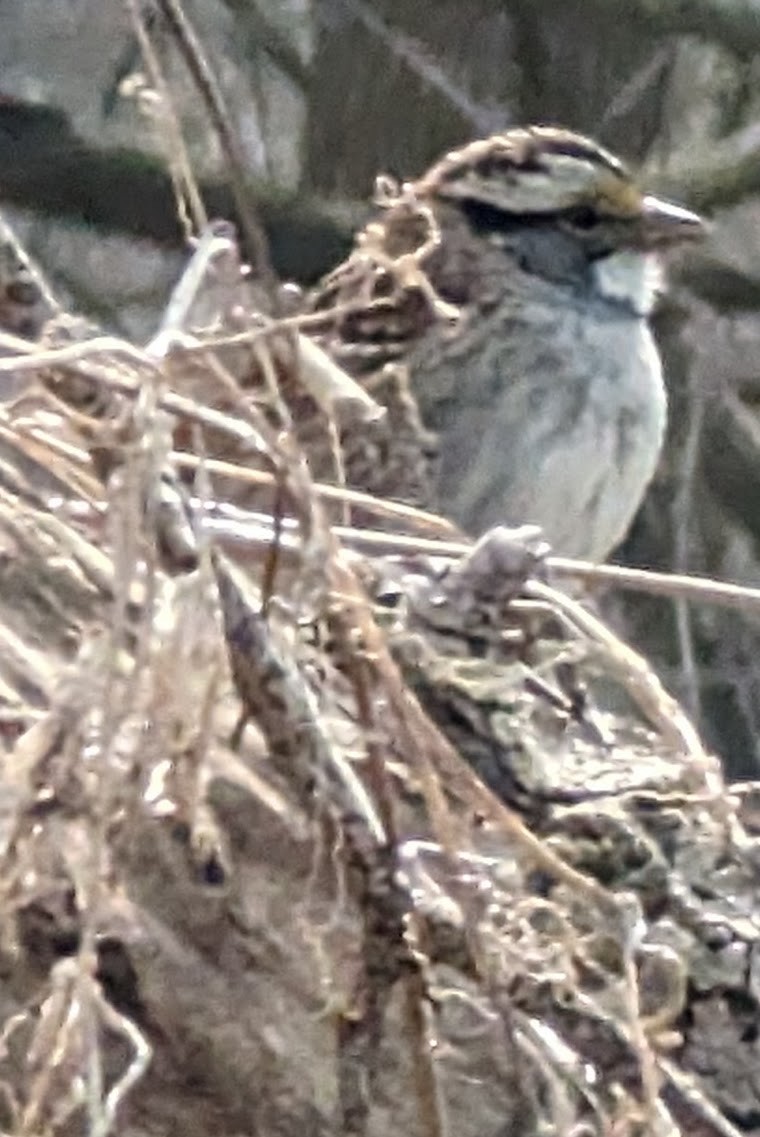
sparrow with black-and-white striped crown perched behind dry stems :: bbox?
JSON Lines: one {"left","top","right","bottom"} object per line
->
{"left": 308, "top": 126, "right": 705, "bottom": 562}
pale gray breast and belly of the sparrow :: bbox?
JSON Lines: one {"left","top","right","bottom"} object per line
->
{"left": 411, "top": 276, "right": 666, "bottom": 559}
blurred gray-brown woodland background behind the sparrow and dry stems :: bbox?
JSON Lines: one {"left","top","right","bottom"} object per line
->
{"left": 0, "top": 0, "right": 760, "bottom": 778}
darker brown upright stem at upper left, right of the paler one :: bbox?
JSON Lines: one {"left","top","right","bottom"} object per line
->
{"left": 156, "top": 0, "right": 278, "bottom": 302}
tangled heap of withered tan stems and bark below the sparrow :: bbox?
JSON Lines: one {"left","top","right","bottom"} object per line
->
{"left": 0, "top": 213, "right": 760, "bottom": 1137}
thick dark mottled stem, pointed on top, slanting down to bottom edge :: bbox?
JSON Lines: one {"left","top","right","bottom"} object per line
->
{"left": 214, "top": 554, "right": 412, "bottom": 1135}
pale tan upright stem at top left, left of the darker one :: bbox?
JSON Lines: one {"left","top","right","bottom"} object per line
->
{"left": 125, "top": 0, "right": 208, "bottom": 238}
